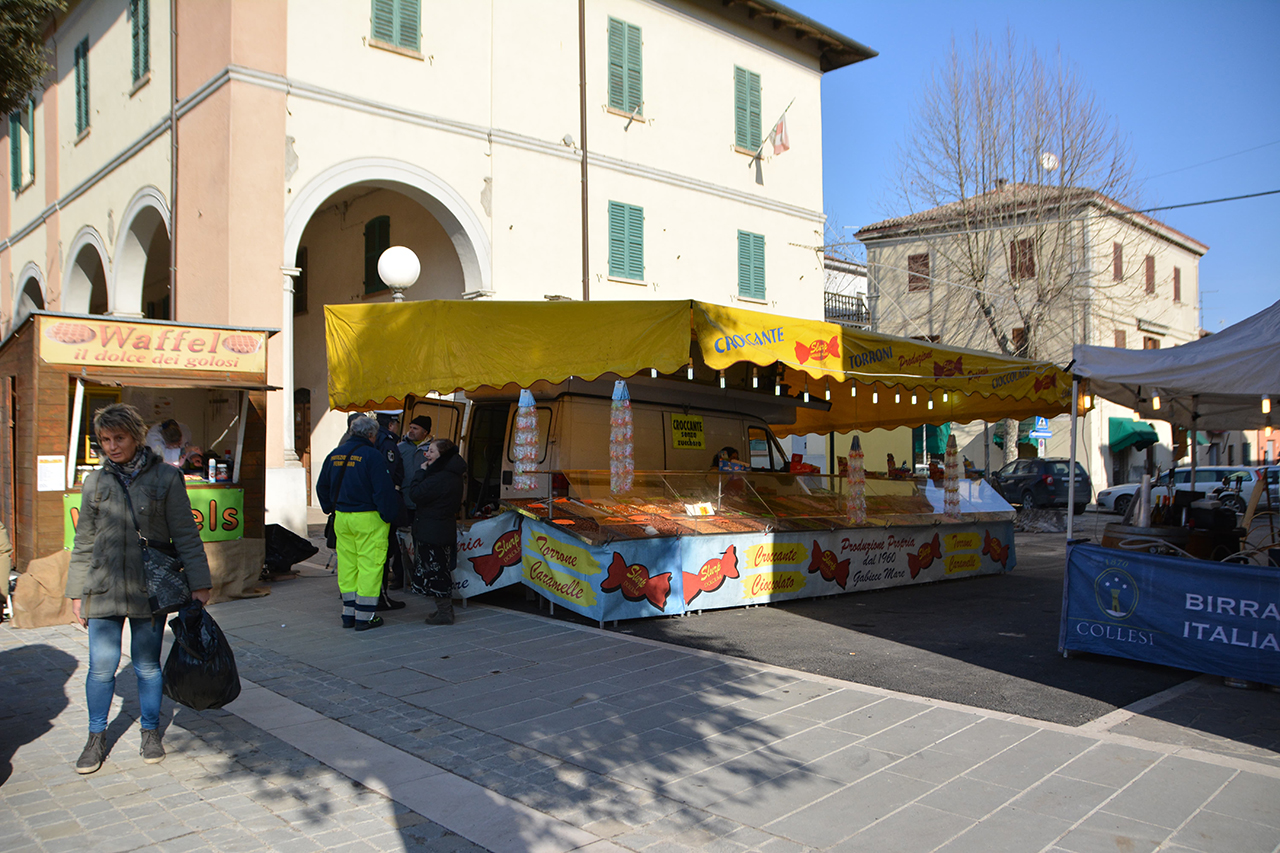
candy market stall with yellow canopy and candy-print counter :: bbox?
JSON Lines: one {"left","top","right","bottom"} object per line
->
{"left": 325, "top": 300, "right": 1071, "bottom": 621}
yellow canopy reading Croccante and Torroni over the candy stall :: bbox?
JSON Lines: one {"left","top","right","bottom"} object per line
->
{"left": 325, "top": 300, "right": 1071, "bottom": 435}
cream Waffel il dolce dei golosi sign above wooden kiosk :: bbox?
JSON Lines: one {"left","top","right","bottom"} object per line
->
{"left": 40, "top": 316, "right": 266, "bottom": 373}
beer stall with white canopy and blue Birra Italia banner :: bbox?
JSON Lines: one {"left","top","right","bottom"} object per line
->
{"left": 1059, "top": 302, "right": 1280, "bottom": 684}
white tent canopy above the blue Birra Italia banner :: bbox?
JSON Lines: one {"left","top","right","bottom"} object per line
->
{"left": 1073, "top": 302, "right": 1280, "bottom": 430}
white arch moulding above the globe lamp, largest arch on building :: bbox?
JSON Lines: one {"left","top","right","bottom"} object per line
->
{"left": 283, "top": 158, "right": 493, "bottom": 291}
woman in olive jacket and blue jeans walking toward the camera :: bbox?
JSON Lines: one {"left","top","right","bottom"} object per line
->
{"left": 67, "top": 403, "right": 211, "bottom": 774}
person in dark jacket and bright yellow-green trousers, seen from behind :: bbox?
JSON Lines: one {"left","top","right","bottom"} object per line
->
{"left": 316, "top": 418, "right": 399, "bottom": 631}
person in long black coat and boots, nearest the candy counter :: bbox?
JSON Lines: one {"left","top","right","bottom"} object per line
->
{"left": 408, "top": 438, "right": 467, "bottom": 625}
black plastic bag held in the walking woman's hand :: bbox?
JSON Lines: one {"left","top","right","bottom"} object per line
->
{"left": 164, "top": 601, "right": 239, "bottom": 711}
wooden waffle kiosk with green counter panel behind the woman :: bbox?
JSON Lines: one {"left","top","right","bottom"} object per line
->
{"left": 0, "top": 311, "right": 274, "bottom": 622}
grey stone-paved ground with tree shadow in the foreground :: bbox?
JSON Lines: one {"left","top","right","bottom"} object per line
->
{"left": 0, "top": 550, "right": 1280, "bottom": 853}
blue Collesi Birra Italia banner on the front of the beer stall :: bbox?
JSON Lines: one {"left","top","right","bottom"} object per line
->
{"left": 1059, "top": 544, "right": 1280, "bottom": 684}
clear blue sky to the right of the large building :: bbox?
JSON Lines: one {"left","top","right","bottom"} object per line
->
{"left": 783, "top": 0, "right": 1280, "bottom": 332}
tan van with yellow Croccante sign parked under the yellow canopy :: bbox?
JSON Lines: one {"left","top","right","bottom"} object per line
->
{"left": 402, "top": 377, "right": 803, "bottom": 515}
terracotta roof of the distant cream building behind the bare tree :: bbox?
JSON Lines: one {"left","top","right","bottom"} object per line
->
{"left": 855, "top": 183, "right": 1208, "bottom": 255}
